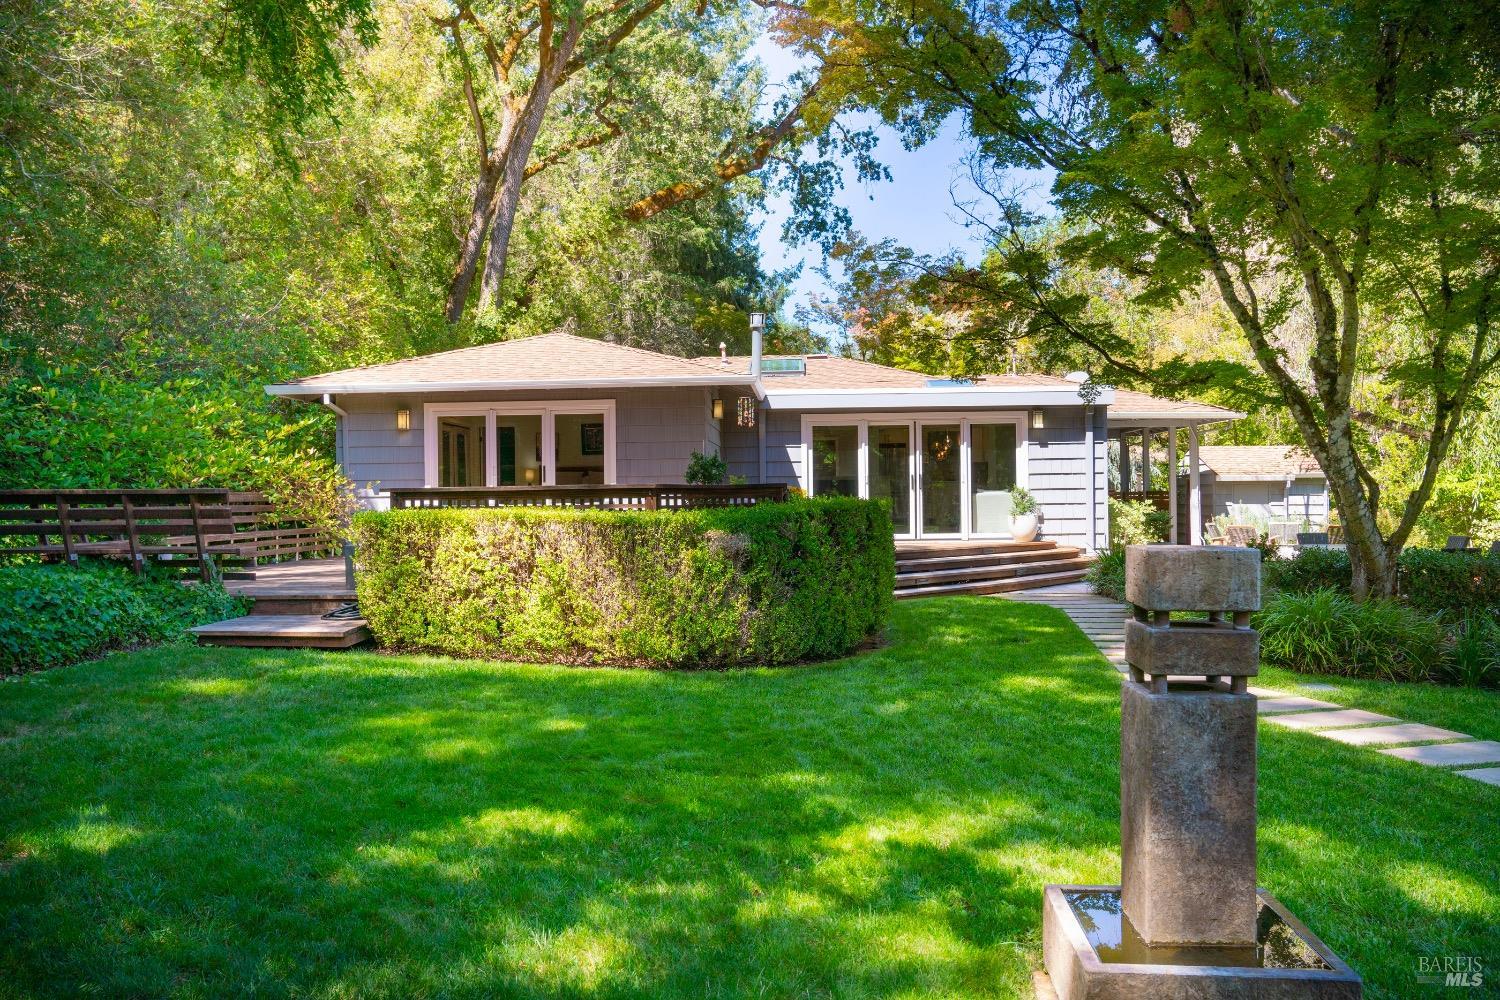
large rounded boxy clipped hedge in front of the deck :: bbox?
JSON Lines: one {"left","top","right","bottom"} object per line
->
{"left": 354, "top": 498, "right": 896, "bottom": 667}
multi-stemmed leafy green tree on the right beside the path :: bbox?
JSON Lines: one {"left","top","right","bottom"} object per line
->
{"left": 861, "top": 0, "right": 1500, "bottom": 595}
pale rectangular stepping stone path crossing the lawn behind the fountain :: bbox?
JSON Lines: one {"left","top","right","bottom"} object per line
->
{"left": 996, "top": 583, "right": 1500, "bottom": 787}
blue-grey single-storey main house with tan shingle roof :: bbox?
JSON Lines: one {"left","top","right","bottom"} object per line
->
{"left": 267, "top": 333, "right": 1242, "bottom": 552}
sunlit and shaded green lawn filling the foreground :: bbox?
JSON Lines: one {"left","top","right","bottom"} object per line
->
{"left": 0, "top": 598, "right": 1500, "bottom": 997}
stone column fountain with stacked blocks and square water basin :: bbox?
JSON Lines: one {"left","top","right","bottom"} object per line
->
{"left": 1038, "top": 546, "right": 1361, "bottom": 1000}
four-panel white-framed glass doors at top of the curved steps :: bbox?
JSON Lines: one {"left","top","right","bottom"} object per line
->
{"left": 801, "top": 412, "right": 1026, "bottom": 538}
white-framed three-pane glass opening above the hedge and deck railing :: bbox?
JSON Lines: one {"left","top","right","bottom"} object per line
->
{"left": 423, "top": 399, "right": 615, "bottom": 487}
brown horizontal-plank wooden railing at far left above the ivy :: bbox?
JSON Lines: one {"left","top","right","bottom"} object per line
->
{"left": 0, "top": 489, "right": 342, "bottom": 579}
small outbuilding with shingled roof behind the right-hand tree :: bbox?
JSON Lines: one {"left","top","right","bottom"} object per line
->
{"left": 1199, "top": 444, "right": 1329, "bottom": 525}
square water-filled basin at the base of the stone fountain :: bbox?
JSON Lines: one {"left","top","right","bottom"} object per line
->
{"left": 1043, "top": 886, "right": 1361, "bottom": 1000}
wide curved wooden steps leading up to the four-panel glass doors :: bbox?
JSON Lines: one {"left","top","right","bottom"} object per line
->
{"left": 896, "top": 541, "right": 1094, "bottom": 598}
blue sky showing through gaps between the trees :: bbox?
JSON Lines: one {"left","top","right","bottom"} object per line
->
{"left": 752, "top": 36, "right": 1050, "bottom": 335}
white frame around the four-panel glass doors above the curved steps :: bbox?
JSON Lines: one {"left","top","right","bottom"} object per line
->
{"left": 797, "top": 409, "right": 1031, "bottom": 538}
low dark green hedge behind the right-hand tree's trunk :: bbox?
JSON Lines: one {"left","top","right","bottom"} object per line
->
{"left": 1265, "top": 549, "right": 1500, "bottom": 618}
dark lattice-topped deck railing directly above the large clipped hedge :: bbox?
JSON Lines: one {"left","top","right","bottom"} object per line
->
{"left": 390, "top": 483, "right": 788, "bottom": 510}
